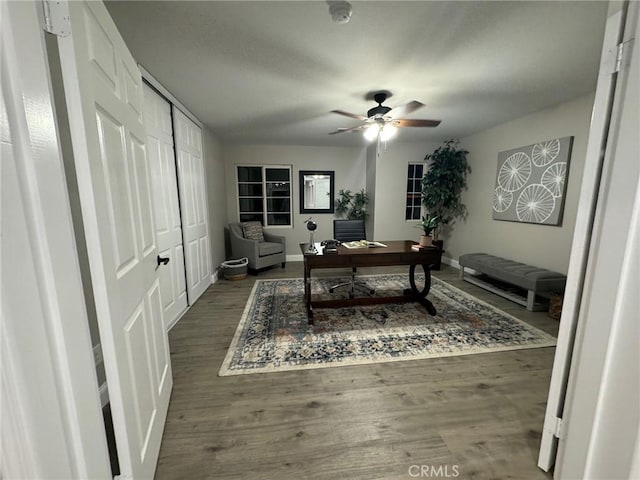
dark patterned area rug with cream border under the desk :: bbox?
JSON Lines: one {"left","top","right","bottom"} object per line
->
{"left": 218, "top": 274, "right": 556, "bottom": 376}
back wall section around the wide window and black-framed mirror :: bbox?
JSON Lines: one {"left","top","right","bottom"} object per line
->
{"left": 222, "top": 145, "right": 366, "bottom": 255}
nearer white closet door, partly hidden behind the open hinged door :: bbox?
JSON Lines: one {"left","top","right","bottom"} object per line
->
{"left": 143, "top": 83, "right": 187, "bottom": 329}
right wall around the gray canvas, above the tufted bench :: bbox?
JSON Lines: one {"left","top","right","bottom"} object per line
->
{"left": 443, "top": 94, "right": 593, "bottom": 273}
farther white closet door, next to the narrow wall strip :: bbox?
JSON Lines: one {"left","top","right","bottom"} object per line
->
{"left": 173, "top": 108, "right": 211, "bottom": 305}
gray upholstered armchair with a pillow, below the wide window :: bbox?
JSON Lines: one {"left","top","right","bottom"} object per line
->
{"left": 229, "top": 222, "right": 287, "bottom": 270}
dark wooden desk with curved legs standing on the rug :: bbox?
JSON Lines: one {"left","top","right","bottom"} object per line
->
{"left": 300, "top": 240, "right": 440, "bottom": 324}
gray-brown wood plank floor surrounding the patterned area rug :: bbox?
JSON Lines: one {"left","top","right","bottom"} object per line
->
{"left": 156, "top": 262, "right": 558, "bottom": 480}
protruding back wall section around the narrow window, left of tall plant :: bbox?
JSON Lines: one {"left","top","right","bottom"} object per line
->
{"left": 374, "top": 141, "right": 439, "bottom": 241}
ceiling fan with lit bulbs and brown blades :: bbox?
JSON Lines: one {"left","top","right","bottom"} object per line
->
{"left": 329, "top": 92, "right": 440, "bottom": 140}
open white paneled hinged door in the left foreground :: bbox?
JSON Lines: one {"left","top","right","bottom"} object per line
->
{"left": 58, "top": 1, "right": 172, "bottom": 478}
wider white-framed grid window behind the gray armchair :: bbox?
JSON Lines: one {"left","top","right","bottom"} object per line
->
{"left": 236, "top": 165, "right": 291, "bottom": 227}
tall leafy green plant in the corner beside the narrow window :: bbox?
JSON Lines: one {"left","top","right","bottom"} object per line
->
{"left": 422, "top": 140, "right": 471, "bottom": 239}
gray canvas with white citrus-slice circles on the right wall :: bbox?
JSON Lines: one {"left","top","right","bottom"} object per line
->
{"left": 493, "top": 137, "right": 573, "bottom": 226}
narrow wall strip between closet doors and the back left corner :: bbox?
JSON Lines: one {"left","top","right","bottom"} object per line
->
{"left": 202, "top": 125, "right": 228, "bottom": 272}
